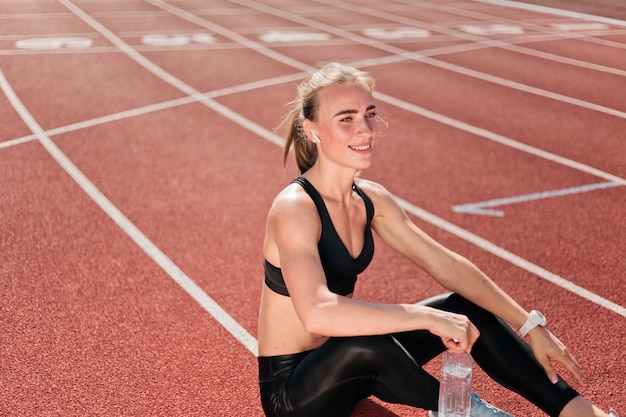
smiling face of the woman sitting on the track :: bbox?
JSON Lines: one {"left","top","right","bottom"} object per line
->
{"left": 310, "top": 83, "right": 378, "bottom": 170}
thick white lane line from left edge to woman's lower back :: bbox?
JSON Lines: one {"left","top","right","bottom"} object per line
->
{"left": 0, "top": 71, "right": 258, "bottom": 356}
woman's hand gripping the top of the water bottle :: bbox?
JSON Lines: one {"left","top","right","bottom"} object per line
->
{"left": 430, "top": 310, "right": 480, "bottom": 353}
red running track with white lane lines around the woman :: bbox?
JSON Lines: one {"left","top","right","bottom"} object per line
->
{"left": 0, "top": 0, "right": 626, "bottom": 417}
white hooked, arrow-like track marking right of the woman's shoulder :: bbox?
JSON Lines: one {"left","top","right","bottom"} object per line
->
{"left": 452, "top": 181, "right": 623, "bottom": 217}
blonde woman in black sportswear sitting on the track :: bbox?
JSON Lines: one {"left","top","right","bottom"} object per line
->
{"left": 258, "top": 64, "right": 607, "bottom": 417}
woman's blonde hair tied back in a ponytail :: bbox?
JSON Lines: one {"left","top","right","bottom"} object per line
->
{"left": 277, "top": 62, "right": 374, "bottom": 174}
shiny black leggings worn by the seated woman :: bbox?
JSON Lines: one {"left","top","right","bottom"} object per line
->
{"left": 259, "top": 294, "right": 578, "bottom": 417}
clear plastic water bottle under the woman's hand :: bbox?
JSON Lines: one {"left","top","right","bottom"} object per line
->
{"left": 439, "top": 351, "right": 474, "bottom": 417}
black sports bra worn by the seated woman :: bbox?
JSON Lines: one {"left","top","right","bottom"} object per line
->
{"left": 263, "top": 177, "right": 374, "bottom": 296}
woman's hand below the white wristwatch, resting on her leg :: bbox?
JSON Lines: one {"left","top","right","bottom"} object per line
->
{"left": 528, "top": 326, "right": 584, "bottom": 384}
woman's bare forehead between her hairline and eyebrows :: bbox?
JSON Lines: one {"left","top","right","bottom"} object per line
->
{"left": 318, "top": 83, "right": 375, "bottom": 115}
